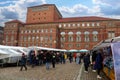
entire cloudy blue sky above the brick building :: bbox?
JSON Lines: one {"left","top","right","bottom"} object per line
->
{"left": 0, "top": 0, "right": 120, "bottom": 26}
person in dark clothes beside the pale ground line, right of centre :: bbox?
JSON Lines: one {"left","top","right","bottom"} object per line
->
{"left": 83, "top": 52, "right": 90, "bottom": 73}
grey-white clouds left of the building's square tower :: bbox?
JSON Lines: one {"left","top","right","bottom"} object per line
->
{"left": 0, "top": 0, "right": 46, "bottom": 26}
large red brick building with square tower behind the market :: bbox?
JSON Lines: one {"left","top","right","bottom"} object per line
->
{"left": 3, "top": 4, "right": 120, "bottom": 50}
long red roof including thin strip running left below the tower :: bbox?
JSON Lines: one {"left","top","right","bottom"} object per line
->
{"left": 25, "top": 16, "right": 120, "bottom": 24}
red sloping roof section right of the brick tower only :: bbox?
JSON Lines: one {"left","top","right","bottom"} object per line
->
{"left": 57, "top": 16, "right": 120, "bottom": 22}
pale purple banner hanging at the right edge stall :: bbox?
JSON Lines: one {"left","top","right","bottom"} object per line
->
{"left": 111, "top": 42, "right": 120, "bottom": 80}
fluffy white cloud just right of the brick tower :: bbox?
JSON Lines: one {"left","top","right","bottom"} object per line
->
{"left": 59, "top": 4, "right": 102, "bottom": 17}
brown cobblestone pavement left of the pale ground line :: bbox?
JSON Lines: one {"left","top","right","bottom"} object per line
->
{"left": 0, "top": 62, "right": 81, "bottom": 80}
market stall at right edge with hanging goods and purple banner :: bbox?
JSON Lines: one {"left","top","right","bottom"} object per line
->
{"left": 93, "top": 36, "right": 120, "bottom": 80}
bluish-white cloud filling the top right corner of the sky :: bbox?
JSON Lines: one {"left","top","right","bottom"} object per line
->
{"left": 93, "top": 0, "right": 120, "bottom": 16}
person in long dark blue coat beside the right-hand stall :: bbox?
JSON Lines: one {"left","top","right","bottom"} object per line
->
{"left": 95, "top": 51, "right": 103, "bottom": 79}
